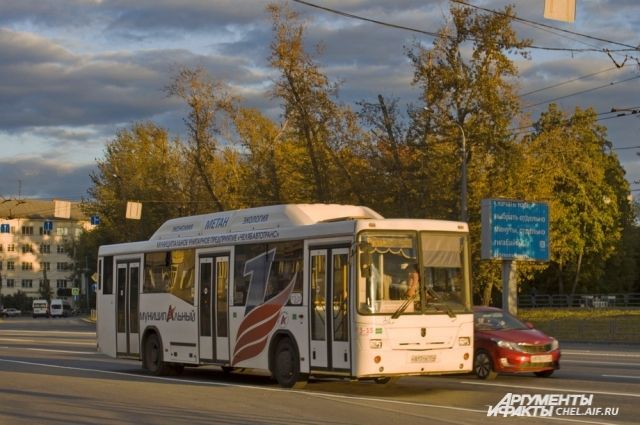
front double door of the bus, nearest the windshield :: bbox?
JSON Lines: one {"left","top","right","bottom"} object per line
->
{"left": 309, "top": 248, "right": 351, "bottom": 370}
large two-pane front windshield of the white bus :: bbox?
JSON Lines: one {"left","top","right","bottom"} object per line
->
{"left": 357, "top": 231, "right": 470, "bottom": 317}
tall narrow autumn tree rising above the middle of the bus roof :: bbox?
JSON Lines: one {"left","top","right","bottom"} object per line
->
{"left": 268, "top": 4, "right": 364, "bottom": 203}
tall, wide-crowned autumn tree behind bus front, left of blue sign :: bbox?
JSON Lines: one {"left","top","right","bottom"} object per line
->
{"left": 408, "top": 7, "right": 529, "bottom": 303}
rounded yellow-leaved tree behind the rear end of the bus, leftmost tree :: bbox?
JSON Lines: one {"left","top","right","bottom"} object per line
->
{"left": 85, "top": 122, "right": 189, "bottom": 242}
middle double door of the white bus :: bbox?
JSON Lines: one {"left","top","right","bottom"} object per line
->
{"left": 198, "top": 253, "right": 229, "bottom": 362}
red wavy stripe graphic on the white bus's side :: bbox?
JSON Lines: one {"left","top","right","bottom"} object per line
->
{"left": 231, "top": 273, "right": 297, "bottom": 365}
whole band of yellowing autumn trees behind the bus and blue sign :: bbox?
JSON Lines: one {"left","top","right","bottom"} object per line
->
{"left": 76, "top": 0, "right": 640, "bottom": 303}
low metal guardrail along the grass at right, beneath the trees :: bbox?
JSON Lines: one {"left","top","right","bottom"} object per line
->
{"left": 518, "top": 293, "right": 640, "bottom": 308}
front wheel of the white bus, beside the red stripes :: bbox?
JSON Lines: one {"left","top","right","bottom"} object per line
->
{"left": 269, "top": 331, "right": 308, "bottom": 388}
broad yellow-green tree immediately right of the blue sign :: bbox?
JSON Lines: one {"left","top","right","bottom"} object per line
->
{"left": 523, "top": 105, "right": 632, "bottom": 295}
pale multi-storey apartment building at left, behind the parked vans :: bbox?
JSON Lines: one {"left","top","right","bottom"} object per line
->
{"left": 0, "top": 199, "right": 91, "bottom": 298}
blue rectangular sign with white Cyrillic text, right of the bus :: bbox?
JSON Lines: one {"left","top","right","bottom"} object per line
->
{"left": 481, "top": 199, "right": 549, "bottom": 261}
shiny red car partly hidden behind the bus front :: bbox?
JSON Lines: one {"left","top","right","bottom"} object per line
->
{"left": 473, "top": 307, "right": 560, "bottom": 379}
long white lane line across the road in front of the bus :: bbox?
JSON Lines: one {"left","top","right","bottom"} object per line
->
{"left": 0, "top": 358, "right": 624, "bottom": 425}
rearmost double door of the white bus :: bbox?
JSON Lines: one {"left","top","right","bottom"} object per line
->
{"left": 116, "top": 261, "right": 140, "bottom": 356}
